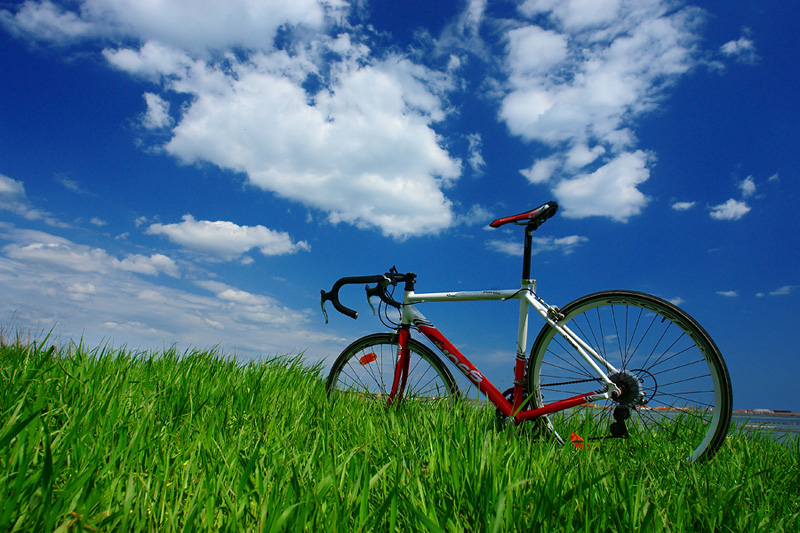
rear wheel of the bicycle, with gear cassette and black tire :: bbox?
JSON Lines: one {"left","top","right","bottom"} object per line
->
{"left": 528, "top": 291, "right": 733, "bottom": 463}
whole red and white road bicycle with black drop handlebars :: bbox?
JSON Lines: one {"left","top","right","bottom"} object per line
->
{"left": 321, "top": 201, "right": 732, "bottom": 463}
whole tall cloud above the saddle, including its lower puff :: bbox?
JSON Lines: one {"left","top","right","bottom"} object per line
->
{"left": 500, "top": 0, "right": 702, "bottom": 221}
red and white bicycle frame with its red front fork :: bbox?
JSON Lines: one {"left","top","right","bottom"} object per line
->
{"left": 389, "top": 280, "right": 619, "bottom": 421}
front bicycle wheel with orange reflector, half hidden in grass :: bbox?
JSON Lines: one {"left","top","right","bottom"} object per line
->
{"left": 325, "top": 333, "right": 460, "bottom": 404}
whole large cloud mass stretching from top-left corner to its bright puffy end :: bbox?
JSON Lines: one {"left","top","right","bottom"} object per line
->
{"left": 2, "top": 0, "right": 462, "bottom": 238}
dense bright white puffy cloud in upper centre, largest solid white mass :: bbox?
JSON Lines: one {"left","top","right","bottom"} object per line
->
{"left": 150, "top": 50, "right": 461, "bottom": 238}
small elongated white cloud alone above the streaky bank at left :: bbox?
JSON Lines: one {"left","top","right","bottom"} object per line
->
{"left": 146, "top": 215, "right": 311, "bottom": 260}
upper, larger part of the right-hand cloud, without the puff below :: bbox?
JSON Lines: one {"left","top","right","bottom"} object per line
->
{"left": 501, "top": 1, "right": 696, "bottom": 147}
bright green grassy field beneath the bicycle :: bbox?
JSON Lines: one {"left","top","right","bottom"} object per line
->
{"left": 0, "top": 343, "right": 800, "bottom": 531}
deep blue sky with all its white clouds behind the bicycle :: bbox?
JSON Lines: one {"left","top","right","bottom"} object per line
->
{"left": 0, "top": 0, "right": 800, "bottom": 411}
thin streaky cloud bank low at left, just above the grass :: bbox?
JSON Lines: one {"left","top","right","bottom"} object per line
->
{"left": 0, "top": 229, "right": 334, "bottom": 362}
